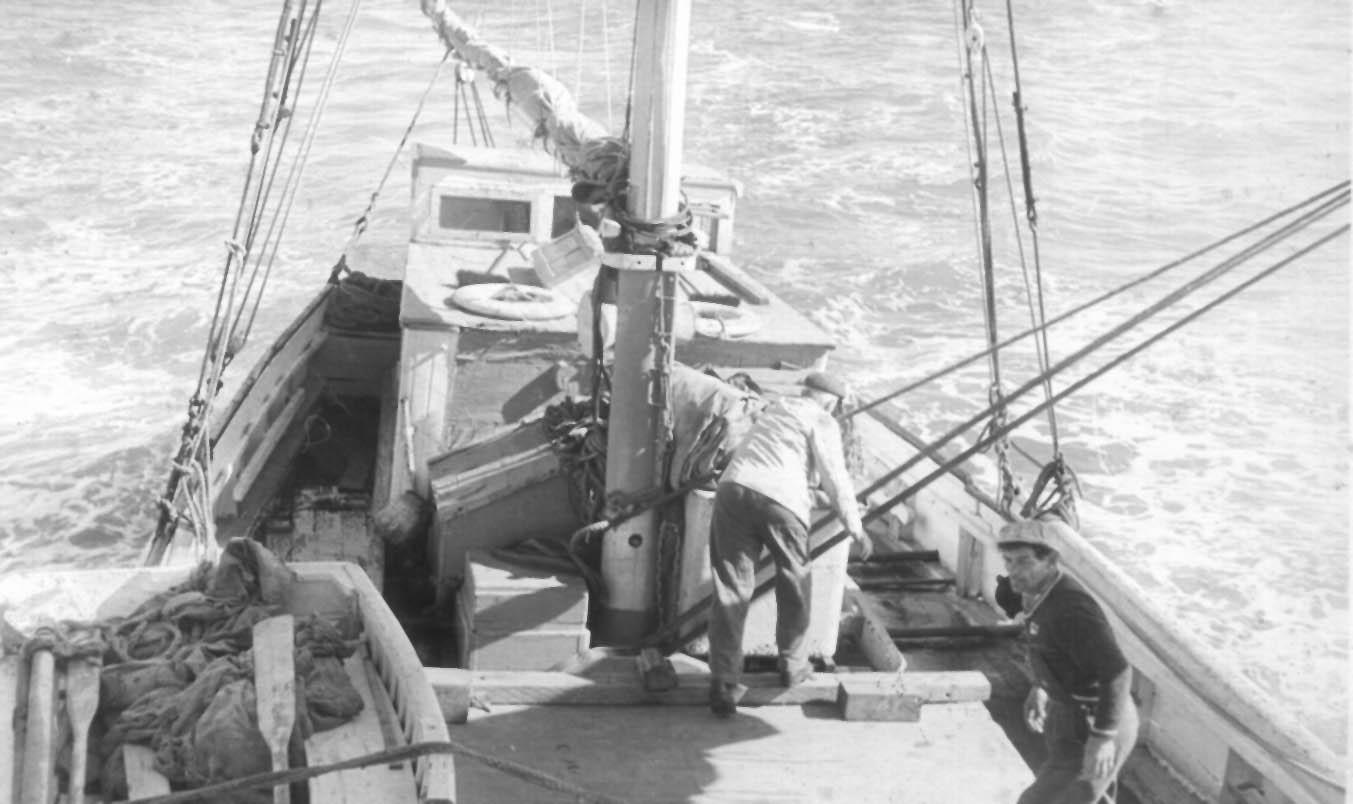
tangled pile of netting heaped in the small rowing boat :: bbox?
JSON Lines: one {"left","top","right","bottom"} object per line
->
{"left": 20, "top": 539, "right": 363, "bottom": 804}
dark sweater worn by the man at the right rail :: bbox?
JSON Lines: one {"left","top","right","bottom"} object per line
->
{"left": 1026, "top": 574, "right": 1131, "bottom": 734}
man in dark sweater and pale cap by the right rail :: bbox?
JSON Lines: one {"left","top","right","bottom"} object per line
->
{"left": 997, "top": 520, "right": 1138, "bottom": 804}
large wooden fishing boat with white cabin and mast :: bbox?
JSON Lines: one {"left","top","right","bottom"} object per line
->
{"left": 0, "top": 0, "right": 1345, "bottom": 804}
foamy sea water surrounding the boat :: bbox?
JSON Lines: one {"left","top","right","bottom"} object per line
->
{"left": 0, "top": 0, "right": 1350, "bottom": 751}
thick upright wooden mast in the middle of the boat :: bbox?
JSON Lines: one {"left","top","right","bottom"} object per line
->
{"left": 595, "top": 0, "right": 690, "bottom": 644}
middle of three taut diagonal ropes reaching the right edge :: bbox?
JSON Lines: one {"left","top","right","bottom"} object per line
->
{"left": 859, "top": 192, "right": 1348, "bottom": 495}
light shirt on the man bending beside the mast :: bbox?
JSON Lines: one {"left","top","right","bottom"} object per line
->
{"left": 720, "top": 397, "right": 865, "bottom": 533}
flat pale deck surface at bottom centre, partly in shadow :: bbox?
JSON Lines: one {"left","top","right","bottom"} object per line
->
{"left": 449, "top": 702, "right": 1032, "bottom": 804}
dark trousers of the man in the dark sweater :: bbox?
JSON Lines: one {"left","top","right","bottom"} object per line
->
{"left": 1019, "top": 700, "right": 1137, "bottom": 804}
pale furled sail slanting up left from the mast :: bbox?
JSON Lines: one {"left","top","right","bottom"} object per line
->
{"left": 422, "top": 0, "right": 614, "bottom": 176}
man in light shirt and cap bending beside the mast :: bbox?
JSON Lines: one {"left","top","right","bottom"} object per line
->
{"left": 709, "top": 372, "right": 870, "bottom": 717}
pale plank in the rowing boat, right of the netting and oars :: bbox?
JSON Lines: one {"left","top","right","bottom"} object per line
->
{"left": 306, "top": 654, "right": 418, "bottom": 804}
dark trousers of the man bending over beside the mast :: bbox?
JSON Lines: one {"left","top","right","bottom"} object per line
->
{"left": 709, "top": 483, "right": 810, "bottom": 684}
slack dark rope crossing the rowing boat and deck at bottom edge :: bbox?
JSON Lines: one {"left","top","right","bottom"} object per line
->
{"left": 125, "top": 740, "right": 622, "bottom": 804}
